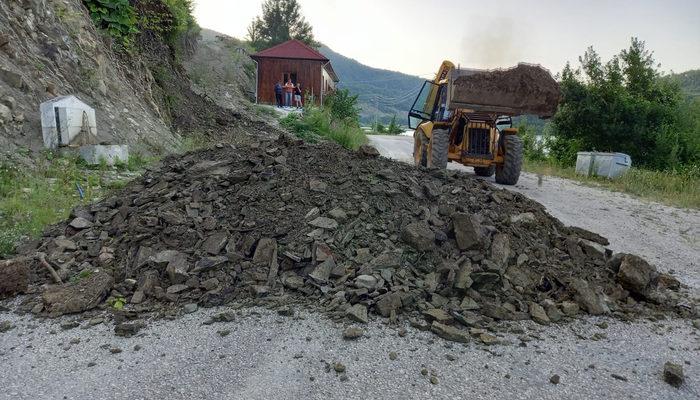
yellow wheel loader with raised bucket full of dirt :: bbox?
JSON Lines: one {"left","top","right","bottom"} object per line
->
{"left": 408, "top": 61, "right": 559, "bottom": 185}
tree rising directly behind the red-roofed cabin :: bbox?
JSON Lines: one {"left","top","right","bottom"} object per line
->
{"left": 248, "top": 0, "right": 320, "bottom": 50}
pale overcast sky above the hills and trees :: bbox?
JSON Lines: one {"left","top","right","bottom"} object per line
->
{"left": 194, "top": 0, "right": 700, "bottom": 77}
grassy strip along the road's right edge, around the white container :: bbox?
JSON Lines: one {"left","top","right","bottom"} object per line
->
{"left": 523, "top": 160, "right": 700, "bottom": 209}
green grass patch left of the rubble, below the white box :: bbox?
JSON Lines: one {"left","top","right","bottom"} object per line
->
{"left": 0, "top": 153, "right": 151, "bottom": 257}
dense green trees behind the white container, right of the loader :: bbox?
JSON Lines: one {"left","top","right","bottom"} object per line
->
{"left": 549, "top": 38, "right": 693, "bottom": 169}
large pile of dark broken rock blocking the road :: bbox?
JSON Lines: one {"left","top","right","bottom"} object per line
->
{"left": 0, "top": 138, "right": 696, "bottom": 341}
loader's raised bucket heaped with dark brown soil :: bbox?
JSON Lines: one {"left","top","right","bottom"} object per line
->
{"left": 451, "top": 63, "right": 559, "bottom": 118}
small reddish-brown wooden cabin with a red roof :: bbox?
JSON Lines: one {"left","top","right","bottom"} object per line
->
{"left": 250, "top": 39, "right": 339, "bottom": 104}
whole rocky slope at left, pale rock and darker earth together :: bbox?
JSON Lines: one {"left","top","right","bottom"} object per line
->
{"left": 0, "top": 0, "right": 278, "bottom": 161}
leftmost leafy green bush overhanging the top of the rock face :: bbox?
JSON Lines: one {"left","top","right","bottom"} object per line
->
{"left": 83, "top": 0, "right": 138, "bottom": 49}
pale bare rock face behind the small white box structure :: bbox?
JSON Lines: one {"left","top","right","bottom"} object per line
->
{"left": 0, "top": 0, "right": 178, "bottom": 152}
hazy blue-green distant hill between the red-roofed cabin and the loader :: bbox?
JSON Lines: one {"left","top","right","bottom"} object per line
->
{"left": 319, "top": 46, "right": 424, "bottom": 125}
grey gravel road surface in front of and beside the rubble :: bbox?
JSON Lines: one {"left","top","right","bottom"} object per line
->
{"left": 0, "top": 136, "right": 700, "bottom": 400}
